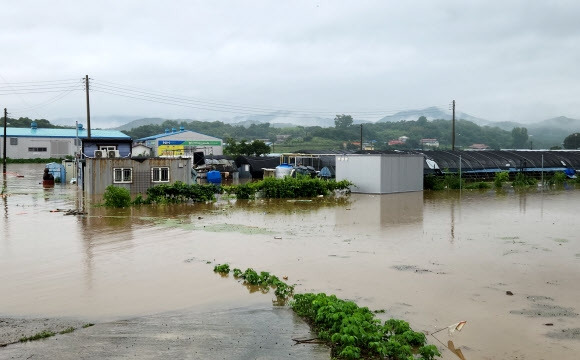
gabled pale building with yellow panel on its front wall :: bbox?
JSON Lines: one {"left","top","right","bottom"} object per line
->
{"left": 136, "top": 126, "right": 223, "bottom": 157}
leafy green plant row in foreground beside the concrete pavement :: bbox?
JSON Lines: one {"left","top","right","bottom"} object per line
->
{"left": 214, "top": 264, "right": 441, "bottom": 360}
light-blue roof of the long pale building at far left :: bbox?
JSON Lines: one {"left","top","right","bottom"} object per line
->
{"left": 0, "top": 127, "right": 131, "bottom": 140}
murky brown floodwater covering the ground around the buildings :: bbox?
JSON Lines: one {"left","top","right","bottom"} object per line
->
{"left": 0, "top": 165, "right": 580, "bottom": 359}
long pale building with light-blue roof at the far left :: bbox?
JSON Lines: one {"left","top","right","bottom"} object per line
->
{"left": 0, "top": 122, "right": 132, "bottom": 159}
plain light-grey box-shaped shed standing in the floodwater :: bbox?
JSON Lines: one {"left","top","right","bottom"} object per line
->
{"left": 336, "top": 153, "right": 424, "bottom": 194}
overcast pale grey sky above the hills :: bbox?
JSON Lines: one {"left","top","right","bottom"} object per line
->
{"left": 0, "top": 0, "right": 580, "bottom": 125}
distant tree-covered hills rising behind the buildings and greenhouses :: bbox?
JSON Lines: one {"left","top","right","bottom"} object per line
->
{"left": 118, "top": 114, "right": 540, "bottom": 153}
